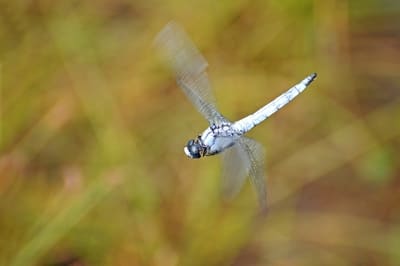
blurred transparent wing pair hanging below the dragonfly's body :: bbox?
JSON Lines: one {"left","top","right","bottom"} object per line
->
{"left": 222, "top": 137, "right": 267, "bottom": 209}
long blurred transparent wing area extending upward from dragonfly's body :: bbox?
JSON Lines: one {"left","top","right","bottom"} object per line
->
{"left": 155, "top": 22, "right": 226, "bottom": 124}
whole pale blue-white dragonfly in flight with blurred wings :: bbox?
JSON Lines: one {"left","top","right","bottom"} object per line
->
{"left": 154, "top": 22, "right": 317, "bottom": 209}
